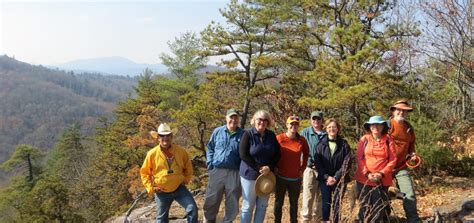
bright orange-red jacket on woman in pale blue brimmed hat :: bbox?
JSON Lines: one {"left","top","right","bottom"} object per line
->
{"left": 354, "top": 134, "right": 397, "bottom": 186}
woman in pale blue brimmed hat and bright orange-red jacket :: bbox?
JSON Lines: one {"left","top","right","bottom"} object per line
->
{"left": 354, "top": 116, "right": 397, "bottom": 222}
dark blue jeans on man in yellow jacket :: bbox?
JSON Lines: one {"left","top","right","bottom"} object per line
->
{"left": 155, "top": 185, "right": 198, "bottom": 223}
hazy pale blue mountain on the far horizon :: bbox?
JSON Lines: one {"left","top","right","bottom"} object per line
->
{"left": 48, "top": 56, "right": 168, "bottom": 77}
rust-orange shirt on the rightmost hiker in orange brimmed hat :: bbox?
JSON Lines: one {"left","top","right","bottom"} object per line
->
{"left": 389, "top": 119, "right": 415, "bottom": 169}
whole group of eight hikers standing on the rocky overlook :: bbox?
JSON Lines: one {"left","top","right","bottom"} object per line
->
{"left": 140, "top": 100, "right": 420, "bottom": 222}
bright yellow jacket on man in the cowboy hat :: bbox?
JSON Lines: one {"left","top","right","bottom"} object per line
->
{"left": 140, "top": 144, "right": 193, "bottom": 193}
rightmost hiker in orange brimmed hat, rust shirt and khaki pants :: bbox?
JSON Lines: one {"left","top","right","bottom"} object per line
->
{"left": 389, "top": 100, "right": 421, "bottom": 223}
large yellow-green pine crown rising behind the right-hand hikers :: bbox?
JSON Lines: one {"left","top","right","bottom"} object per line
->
{"left": 255, "top": 0, "right": 415, "bottom": 138}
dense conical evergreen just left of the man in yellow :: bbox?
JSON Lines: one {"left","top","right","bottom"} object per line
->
{"left": 76, "top": 71, "right": 166, "bottom": 221}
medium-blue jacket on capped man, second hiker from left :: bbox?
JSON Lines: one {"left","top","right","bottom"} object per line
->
{"left": 206, "top": 125, "right": 244, "bottom": 170}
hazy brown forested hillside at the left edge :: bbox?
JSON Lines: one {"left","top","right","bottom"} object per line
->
{"left": 0, "top": 56, "right": 136, "bottom": 163}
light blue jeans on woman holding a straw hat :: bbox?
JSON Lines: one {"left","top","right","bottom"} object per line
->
{"left": 240, "top": 177, "right": 270, "bottom": 223}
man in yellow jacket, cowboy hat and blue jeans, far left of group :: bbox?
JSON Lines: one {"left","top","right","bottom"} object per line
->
{"left": 140, "top": 123, "right": 198, "bottom": 223}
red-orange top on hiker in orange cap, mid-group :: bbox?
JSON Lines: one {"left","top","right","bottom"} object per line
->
{"left": 277, "top": 133, "right": 309, "bottom": 178}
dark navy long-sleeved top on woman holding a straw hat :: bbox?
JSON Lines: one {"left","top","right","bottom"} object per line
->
{"left": 239, "top": 128, "right": 280, "bottom": 180}
